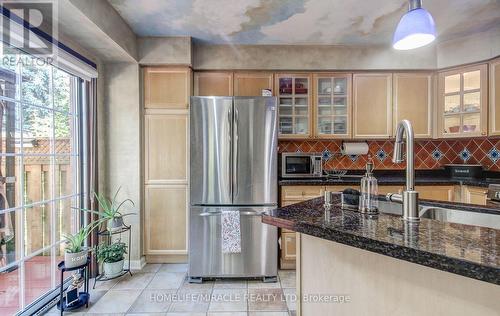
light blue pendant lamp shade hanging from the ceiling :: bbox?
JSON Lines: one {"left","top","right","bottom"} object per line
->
{"left": 392, "top": 8, "right": 436, "bottom": 50}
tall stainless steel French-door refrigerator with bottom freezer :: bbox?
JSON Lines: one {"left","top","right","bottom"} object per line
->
{"left": 189, "top": 97, "right": 278, "bottom": 282}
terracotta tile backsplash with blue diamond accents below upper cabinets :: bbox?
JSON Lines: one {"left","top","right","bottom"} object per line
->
{"left": 279, "top": 138, "right": 500, "bottom": 171}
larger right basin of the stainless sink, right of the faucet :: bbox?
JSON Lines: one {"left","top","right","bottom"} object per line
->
{"left": 420, "top": 206, "right": 500, "bottom": 229}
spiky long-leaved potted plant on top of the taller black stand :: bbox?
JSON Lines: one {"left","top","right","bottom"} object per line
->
{"left": 78, "top": 187, "right": 135, "bottom": 231}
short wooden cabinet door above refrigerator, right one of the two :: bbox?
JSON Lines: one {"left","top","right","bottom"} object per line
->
{"left": 234, "top": 72, "right": 274, "bottom": 97}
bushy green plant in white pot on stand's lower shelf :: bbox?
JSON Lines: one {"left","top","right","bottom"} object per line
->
{"left": 97, "top": 240, "right": 127, "bottom": 278}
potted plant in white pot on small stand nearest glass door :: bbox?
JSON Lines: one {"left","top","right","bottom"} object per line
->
{"left": 63, "top": 223, "right": 97, "bottom": 268}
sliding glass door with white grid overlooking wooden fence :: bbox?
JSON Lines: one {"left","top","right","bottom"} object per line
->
{"left": 0, "top": 47, "right": 85, "bottom": 315}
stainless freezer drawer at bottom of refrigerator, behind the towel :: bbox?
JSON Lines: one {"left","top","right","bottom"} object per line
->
{"left": 189, "top": 207, "right": 278, "bottom": 278}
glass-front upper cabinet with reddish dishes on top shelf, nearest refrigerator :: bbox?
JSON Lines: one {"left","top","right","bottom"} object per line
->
{"left": 275, "top": 74, "right": 312, "bottom": 138}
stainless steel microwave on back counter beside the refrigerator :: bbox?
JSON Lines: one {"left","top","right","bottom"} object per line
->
{"left": 281, "top": 153, "right": 323, "bottom": 178}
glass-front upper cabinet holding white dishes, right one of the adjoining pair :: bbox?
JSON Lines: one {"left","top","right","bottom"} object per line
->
{"left": 313, "top": 74, "right": 352, "bottom": 138}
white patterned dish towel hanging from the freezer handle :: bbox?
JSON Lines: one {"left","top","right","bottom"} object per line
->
{"left": 221, "top": 210, "right": 241, "bottom": 253}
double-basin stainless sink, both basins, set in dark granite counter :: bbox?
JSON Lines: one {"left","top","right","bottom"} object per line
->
{"left": 378, "top": 200, "right": 500, "bottom": 229}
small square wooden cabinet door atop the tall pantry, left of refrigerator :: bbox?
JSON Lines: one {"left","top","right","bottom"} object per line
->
{"left": 144, "top": 67, "right": 191, "bottom": 109}
